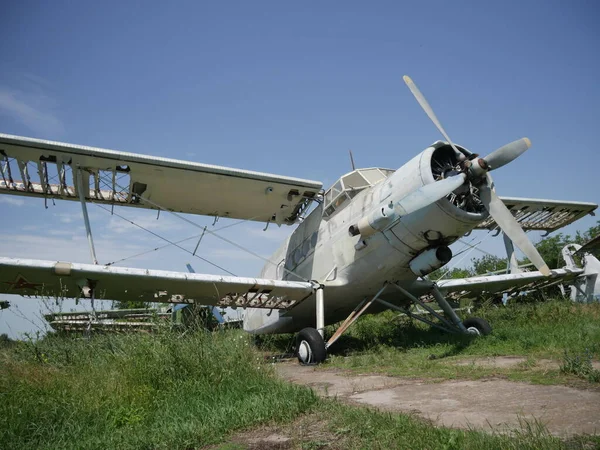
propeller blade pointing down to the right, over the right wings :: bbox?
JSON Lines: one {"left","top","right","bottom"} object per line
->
{"left": 479, "top": 182, "right": 551, "bottom": 276}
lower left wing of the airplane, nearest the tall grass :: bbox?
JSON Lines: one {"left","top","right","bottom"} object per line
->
{"left": 0, "top": 257, "right": 314, "bottom": 309}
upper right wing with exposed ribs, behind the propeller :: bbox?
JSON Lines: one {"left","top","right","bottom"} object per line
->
{"left": 476, "top": 197, "right": 598, "bottom": 233}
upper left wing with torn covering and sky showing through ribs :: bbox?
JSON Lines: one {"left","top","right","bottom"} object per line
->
{"left": 0, "top": 134, "right": 322, "bottom": 224}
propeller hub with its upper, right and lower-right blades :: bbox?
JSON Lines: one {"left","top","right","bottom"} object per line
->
{"left": 401, "top": 75, "right": 551, "bottom": 276}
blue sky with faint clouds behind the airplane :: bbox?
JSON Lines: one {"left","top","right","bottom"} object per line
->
{"left": 0, "top": 0, "right": 600, "bottom": 337}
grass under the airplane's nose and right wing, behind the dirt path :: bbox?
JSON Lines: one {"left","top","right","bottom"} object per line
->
{"left": 265, "top": 300, "right": 600, "bottom": 384}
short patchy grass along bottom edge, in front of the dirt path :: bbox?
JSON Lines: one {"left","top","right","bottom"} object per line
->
{"left": 213, "top": 400, "right": 600, "bottom": 450}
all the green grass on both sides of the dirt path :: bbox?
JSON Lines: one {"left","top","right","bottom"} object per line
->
{"left": 0, "top": 302, "right": 600, "bottom": 449}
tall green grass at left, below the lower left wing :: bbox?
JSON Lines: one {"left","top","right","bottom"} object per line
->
{"left": 0, "top": 331, "right": 317, "bottom": 449}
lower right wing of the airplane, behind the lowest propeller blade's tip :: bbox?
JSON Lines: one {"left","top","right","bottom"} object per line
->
{"left": 437, "top": 269, "right": 584, "bottom": 299}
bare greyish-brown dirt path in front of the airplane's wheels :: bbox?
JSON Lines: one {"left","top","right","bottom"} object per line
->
{"left": 276, "top": 361, "right": 600, "bottom": 437}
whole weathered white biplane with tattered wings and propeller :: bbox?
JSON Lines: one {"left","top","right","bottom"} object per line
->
{"left": 0, "top": 76, "right": 600, "bottom": 364}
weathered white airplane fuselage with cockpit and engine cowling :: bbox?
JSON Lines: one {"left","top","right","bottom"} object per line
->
{"left": 244, "top": 142, "right": 487, "bottom": 333}
